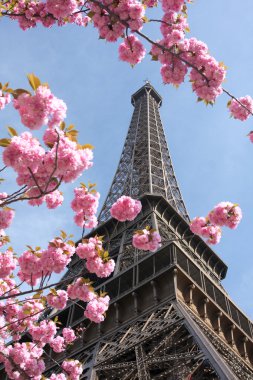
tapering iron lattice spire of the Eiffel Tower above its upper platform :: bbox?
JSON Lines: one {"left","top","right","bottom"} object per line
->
{"left": 99, "top": 83, "right": 189, "bottom": 222}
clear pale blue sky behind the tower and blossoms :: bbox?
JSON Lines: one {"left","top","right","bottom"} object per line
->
{"left": 0, "top": 0, "right": 253, "bottom": 317}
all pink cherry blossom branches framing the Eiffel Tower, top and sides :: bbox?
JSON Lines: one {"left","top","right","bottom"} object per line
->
{"left": 0, "top": 0, "right": 248, "bottom": 380}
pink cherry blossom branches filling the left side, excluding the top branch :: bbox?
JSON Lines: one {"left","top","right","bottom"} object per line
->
{"left": 0, "top": 74, "right": 148, "bottom": 380}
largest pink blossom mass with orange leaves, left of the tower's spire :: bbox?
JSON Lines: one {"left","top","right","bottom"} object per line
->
{"left": 0, "top": 76, "right": 96, "bottom": 229}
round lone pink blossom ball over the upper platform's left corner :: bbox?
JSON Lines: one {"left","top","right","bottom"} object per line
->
{"left": 110, "top": 195, "right": 142, "bottom": 222}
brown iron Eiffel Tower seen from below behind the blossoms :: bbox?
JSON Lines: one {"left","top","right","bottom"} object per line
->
{"left": 44, "top": 82, "right": 253, "bottom": 380}
